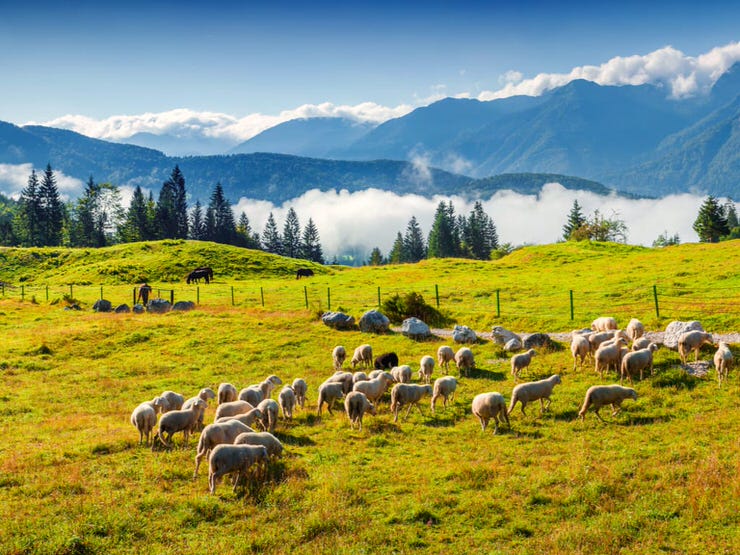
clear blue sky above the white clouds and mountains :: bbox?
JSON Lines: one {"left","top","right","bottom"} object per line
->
{"left": 0, "top": 0, "right": 740, "bottom": 124}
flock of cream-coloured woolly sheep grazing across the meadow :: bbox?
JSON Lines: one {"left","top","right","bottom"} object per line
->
{"left": 131, "top": 317, "right": 733, "bottom": 493}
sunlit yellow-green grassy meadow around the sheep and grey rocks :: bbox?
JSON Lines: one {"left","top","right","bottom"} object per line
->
{"left": 0, "top": 241, "right": 740, "bottom": 554}
